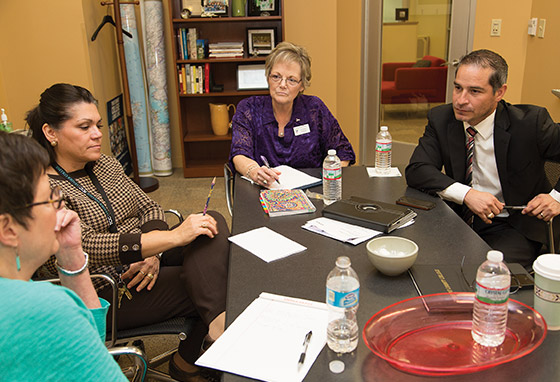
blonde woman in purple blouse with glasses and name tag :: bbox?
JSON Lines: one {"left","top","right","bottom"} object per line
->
{"left": 230, "top": 42, "right": 356, "bottom": 186}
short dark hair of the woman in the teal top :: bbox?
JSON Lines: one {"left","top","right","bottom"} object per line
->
{"left": 0, "top": 131, "right": 49, "bottom": 228}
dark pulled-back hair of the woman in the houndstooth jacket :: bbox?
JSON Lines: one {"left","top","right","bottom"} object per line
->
{"left": 25, "top": 84, "right": 97, "bottom": 163}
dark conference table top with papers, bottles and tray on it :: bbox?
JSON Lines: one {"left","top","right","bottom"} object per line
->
{"left": 223, "top": 166, "right": 560, "bottom": 382}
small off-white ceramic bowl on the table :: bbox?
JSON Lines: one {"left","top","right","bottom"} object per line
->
{"left": 366, "top": 236, "right": 418, "bottom": 276}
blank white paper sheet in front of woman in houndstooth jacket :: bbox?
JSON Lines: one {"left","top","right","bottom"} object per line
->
{"left": 229, "top": 227, "right": 307, "bottom": 263}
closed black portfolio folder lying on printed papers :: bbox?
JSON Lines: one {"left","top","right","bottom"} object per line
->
{"left": 323, "top": 196, "right": 416, "bottom": 233}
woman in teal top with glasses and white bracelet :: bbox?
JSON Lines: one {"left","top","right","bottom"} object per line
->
{"left": 0, "top": 132, "right": 127, "bottom": 381}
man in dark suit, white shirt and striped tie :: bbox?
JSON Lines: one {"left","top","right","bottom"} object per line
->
{"left": 406, "top": 50, "right": 560, "bottom": 266}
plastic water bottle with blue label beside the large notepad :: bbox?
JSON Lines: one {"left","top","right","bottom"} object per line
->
{"left": 327, "top": 256, "right": 360, "bottom": 353}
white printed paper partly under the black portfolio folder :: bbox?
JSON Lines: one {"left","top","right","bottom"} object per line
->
{"left": 301, "top": 217, "right": 383, "bottom": 245}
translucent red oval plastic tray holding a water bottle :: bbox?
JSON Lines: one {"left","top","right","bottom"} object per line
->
{"left": 363, "top": 293, "right": 547, "bottom": 376}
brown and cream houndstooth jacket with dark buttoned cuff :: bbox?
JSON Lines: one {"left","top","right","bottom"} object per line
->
{"left": 38, "top": 154, "right": 168, "bottom": 287}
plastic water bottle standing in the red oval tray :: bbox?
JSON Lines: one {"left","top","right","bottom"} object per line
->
{"left": 471, "top": 251, "right": 511, "bottom": 346}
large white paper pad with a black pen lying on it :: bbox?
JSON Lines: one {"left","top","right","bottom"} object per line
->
{"left": 196, "top": 292, "right": 328, "bottom": 382}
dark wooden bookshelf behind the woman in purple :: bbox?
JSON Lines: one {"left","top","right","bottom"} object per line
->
{"left": 169, "top": 0, "right": 284, "bottom": 178}
